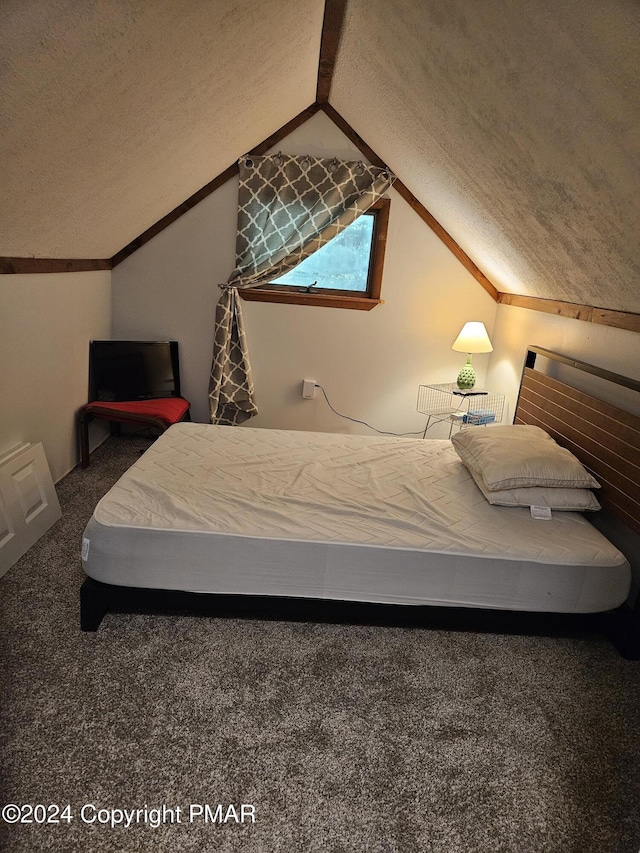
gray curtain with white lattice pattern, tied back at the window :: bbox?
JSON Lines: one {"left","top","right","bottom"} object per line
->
{"left": 209, "top": 154, "right": 395, "bottom": 424}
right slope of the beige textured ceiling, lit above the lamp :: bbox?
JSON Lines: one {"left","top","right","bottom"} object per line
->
{"left": 330, "top": 0, "right": 640, "bottom": 312}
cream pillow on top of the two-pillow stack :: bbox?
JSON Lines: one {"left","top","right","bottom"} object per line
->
{"left": 451, "top": 425, "right": 600, "bottom": 492}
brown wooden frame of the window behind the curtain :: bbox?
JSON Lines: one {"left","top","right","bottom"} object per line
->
{"left": 238, "top": 198, "right": 391, "bottom": 311}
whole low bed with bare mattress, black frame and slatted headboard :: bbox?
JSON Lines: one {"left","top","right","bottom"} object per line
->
{"left": 81, "top": 348, "right": 640, "bottom": 656}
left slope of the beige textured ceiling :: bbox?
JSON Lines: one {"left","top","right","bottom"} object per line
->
{"left": 0, "top": 0, "right": 324, "bottom": 258}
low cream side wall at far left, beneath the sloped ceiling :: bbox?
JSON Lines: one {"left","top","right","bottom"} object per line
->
{"left": 0, "top": 270, "right": 111, "bottom": 481}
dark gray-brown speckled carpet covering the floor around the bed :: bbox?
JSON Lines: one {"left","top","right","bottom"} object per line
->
{"left": 0, "top": 438, "right": 640, "bottom": 853}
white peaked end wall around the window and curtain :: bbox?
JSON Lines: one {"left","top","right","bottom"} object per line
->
{"left": 112, "top": 113, "right": 496, "bottom": 435}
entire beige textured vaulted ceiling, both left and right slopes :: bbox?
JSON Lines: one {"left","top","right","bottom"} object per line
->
{"left": 0, "top": 0, "right": 640, "bottom": 320}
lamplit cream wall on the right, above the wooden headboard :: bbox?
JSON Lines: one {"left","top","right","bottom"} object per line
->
{"left": 487, "top": 305, "right": 640, "bottom": 422}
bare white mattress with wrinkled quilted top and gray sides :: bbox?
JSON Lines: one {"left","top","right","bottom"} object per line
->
{"left": 83, "top": 423, "right": 630, "bottom": 612}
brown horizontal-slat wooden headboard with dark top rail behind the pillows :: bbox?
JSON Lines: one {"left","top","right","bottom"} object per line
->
{"left": 514, "top": 347, "right": 640, "bottom": 533}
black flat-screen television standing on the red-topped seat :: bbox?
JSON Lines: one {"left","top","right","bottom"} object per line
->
{"left": 89, "top": 341, "right": 180, "bottom": 403}
